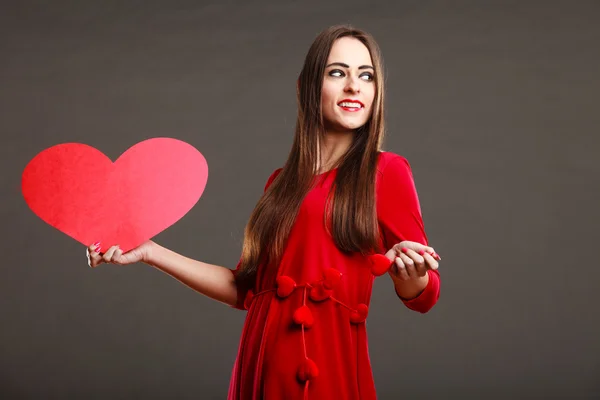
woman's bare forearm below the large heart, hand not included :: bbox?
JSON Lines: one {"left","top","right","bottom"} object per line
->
{"left": 143, "top": 242, "right": 238, "bottom": 306}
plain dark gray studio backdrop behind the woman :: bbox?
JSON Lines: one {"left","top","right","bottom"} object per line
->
{"left": 0, "top": 0, "right": 600, "bottom": 399}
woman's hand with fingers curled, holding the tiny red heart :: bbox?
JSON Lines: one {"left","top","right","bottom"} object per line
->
{"left": 385, "top": 240, "right": 442, "bottom": 281}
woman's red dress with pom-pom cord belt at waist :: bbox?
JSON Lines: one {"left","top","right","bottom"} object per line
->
{"left": 228, "top": 152, "right": 440, "bottom": 400}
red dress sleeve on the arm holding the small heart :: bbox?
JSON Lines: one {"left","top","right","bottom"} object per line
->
{"left": 377, "top": 155, "right": 441, "bottom": 313}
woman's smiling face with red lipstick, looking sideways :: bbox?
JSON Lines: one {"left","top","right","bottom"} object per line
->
{"left": 321, "top": 37, "right": 375, "bottom": 132}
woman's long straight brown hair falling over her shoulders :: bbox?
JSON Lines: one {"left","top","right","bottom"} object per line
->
{"left": 236, "top": 26, "right": 384, "bottom": 288}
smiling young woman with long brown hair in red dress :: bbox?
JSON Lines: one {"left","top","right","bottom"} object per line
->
{"left": 88, "top": 26, "right": 440, "bottom": 400}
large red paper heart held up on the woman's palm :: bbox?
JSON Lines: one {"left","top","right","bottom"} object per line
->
{"left": 21, "top": 138, "right": 208, "bottom": 252}
